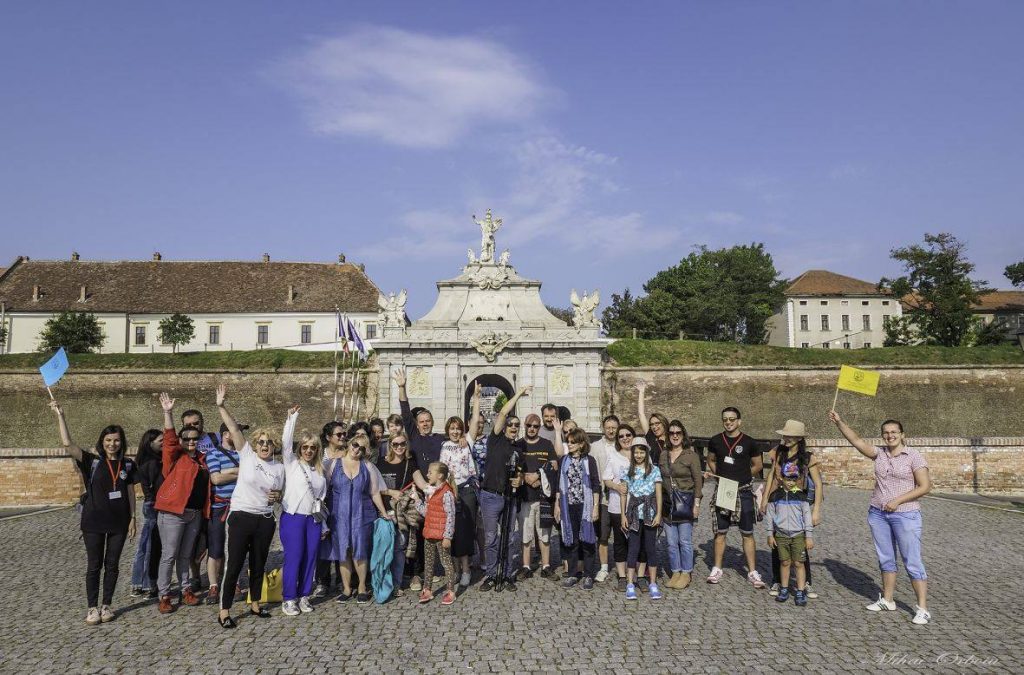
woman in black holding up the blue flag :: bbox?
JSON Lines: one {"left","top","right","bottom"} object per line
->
{"left": 50, "top": 400, "right": 135, "bottom": 626}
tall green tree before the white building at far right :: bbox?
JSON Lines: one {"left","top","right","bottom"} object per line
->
{"left": 879, "top": 233, "right": 991, "bottom": 347}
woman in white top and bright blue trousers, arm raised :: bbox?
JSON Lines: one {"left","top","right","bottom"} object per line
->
{"left": 281, "top": 406, "right": 328, "bottom": 617}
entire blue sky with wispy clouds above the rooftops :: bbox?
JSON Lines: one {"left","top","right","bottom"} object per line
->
{"left": 0, "top": 1, "right": 1024, "bottom": 318}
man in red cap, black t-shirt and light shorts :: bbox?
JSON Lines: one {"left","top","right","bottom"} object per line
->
{"left": 517, "top": 414, "right": 558, "bottom": 579}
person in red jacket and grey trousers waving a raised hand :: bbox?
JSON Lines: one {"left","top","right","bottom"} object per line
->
{"left": 154, "top": 393, "right": 210, "bottom": 614}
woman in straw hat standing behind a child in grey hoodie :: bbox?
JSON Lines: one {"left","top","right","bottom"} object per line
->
{"left": 758, "top": 420, "right": 824, "bottom": 600}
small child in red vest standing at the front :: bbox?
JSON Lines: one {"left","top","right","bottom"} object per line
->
{"left": 416, "top": 462, "right": 456, "bottom": 604}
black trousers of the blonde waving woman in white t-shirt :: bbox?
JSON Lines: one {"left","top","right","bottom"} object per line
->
{"left": 220, "top": 511, "right": 278, "bottom": 609}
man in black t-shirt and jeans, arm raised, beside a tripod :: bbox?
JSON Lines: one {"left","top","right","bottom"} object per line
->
{"left": 480, "top": 387, "right": 531, "bottom": 591}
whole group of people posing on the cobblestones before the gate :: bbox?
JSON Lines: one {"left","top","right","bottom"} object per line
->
{"left": 50, "top": 370, "right": 931, "bottom": 628}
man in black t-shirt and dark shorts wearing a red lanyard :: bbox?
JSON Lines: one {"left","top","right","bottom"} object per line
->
{"left": 706, "top": 407, "right": 765, "bottom": 588}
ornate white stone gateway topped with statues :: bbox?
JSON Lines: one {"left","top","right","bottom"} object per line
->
{"left": 374, "top": 210, "right": 608, "bottom": 430}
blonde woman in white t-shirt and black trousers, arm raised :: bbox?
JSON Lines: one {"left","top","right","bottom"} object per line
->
{"left": 217, "top": 384, "right": 285, "bottom": 628}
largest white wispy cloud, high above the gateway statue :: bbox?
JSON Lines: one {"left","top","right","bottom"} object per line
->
{"left": 271, "top": 27, "right": 559, "bottom": 149}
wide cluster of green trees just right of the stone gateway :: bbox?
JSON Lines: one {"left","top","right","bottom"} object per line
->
{"left": 631, "top": 244, "right": 786, "bottom": 344}
